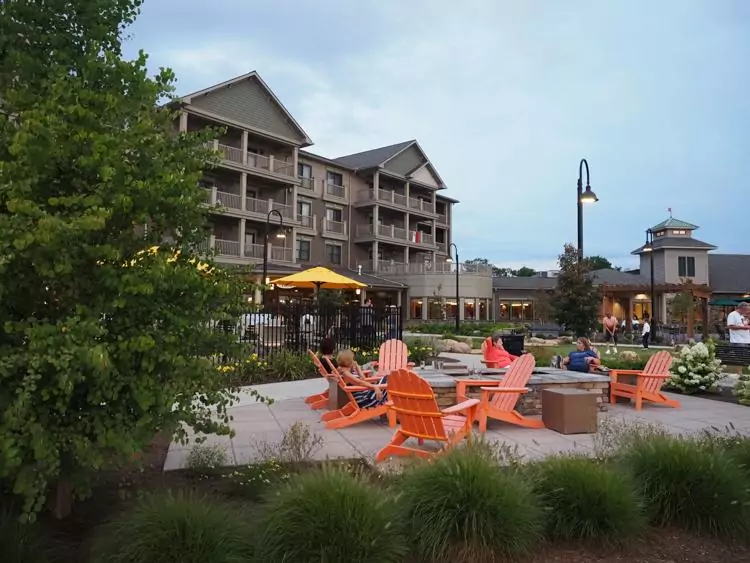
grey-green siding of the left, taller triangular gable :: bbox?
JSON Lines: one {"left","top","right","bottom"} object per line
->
{"left": 191, "top": 78, "right": 305, "bottom": 144}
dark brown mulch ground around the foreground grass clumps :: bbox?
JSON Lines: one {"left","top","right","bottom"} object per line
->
{"left": 20, "top": 435, "right": 750, "bottom": 563}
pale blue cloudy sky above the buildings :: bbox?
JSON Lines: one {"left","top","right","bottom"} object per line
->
{"left": 126, "top": 0, "right": 750, "bottom": 269}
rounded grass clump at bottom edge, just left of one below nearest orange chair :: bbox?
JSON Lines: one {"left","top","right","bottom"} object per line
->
{"left": 257, "top": 467, "right": 406, "bottom": 563}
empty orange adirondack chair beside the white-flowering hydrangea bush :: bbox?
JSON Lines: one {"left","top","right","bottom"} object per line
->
{"left": 609, "top": 350, "right": 680, "bottom": 411}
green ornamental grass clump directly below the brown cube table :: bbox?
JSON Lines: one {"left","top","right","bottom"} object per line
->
{"left": 533, "top": 457, "right": 645, "bottom": 544}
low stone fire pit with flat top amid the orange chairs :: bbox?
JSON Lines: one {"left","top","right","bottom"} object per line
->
{"left": 415, "top": 368, "right": 609, "bottom": 416}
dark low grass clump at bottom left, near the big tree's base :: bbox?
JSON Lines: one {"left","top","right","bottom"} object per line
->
{"left": 91, "top": 494, "right": 253, "bottom": 563}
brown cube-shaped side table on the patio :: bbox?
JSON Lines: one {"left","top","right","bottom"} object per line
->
{"left": 542, "top": 389, "right": 599, "bottom": 434}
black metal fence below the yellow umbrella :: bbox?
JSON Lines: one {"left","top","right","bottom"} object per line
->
{"left": 217, "top": 303, "right": 403, "bottom": 356}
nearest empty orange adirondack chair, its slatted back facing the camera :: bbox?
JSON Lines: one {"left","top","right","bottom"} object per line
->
{"left": 375, "top": 369, "right": 479, "bottom": 461}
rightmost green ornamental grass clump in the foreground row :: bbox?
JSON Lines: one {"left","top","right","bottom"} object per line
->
{"left": 623, "top": 436, "right": 748, "bottom": 536}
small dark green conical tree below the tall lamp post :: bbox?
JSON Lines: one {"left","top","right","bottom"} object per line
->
{"left": 552, "top": 244, "right": 601, "bottom": 336}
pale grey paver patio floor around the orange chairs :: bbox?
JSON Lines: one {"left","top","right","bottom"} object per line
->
{"left": 164, "top": 354, "right": 750, "bottom": 471}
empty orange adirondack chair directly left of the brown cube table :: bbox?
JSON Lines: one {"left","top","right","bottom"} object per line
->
{"left": 456, "top": 354, "right": 544, "bottom": 432}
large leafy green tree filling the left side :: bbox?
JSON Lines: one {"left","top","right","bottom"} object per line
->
{"left": 0, "top": 0, "right": 251, "bottom": 515}
